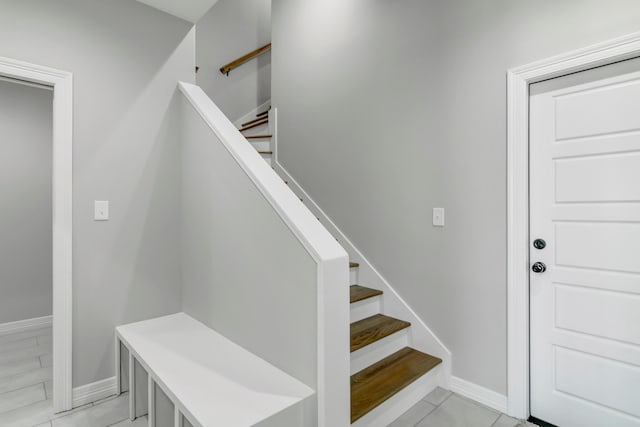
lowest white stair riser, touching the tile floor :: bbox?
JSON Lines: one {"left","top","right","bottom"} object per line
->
{"left": 351, "top": 365, "right": 441, "bottom": 427}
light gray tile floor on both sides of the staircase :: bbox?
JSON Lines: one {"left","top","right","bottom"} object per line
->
{"left": 0, "top": 328, "right": 531, "bottom": 427}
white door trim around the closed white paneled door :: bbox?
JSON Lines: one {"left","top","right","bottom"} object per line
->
{"left": 507, "top": 32, "right": 640, "bottom": 419}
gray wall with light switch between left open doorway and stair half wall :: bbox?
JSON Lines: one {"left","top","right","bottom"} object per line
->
{"left": 0, "top": 0, "right": 195, "bottom": 386}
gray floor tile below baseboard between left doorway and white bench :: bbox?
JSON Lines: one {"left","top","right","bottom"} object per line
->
{"left": 52, "top": 394, "right": 129, "bottom": 427}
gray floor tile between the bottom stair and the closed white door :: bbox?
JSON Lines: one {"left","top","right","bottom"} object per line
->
{"left": 418, "top": 394, "right": 500, "bottom": 427}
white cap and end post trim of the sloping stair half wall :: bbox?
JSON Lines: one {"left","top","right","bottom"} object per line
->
{"left": 179, "top": 82, "right": 350, "bottom": 427}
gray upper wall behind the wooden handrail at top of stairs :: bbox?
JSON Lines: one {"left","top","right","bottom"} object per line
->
{"left": 196, "top": 0, "right": 271, "bottom": 120}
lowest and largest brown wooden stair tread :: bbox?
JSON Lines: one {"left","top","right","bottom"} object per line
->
{"left": 351, "top": 347, "right": 442, "bottom": 423}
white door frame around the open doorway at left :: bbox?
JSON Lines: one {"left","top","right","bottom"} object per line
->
{"left": 0, "top": 57, "right": 73, "bottom": 412}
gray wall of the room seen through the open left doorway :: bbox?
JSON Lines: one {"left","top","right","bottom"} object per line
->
{"left": 0, "top": 80, "right": 53, "bottom": 323}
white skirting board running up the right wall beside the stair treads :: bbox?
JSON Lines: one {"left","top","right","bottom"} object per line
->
{"left": 272, "top": 124, "right": 452, "bottom": 388}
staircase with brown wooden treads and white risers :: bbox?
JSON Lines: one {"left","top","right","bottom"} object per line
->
{"left": 239, "top": 107, "right": 442, "bottom": 427}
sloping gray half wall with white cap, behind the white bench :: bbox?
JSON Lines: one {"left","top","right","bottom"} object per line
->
{"left": 177, "top": 83, "right": 350, "bottom": 427}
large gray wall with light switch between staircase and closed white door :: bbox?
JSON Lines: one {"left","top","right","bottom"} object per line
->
{"left": 272, "top": 0, "right": 640, "bottom": 393}
